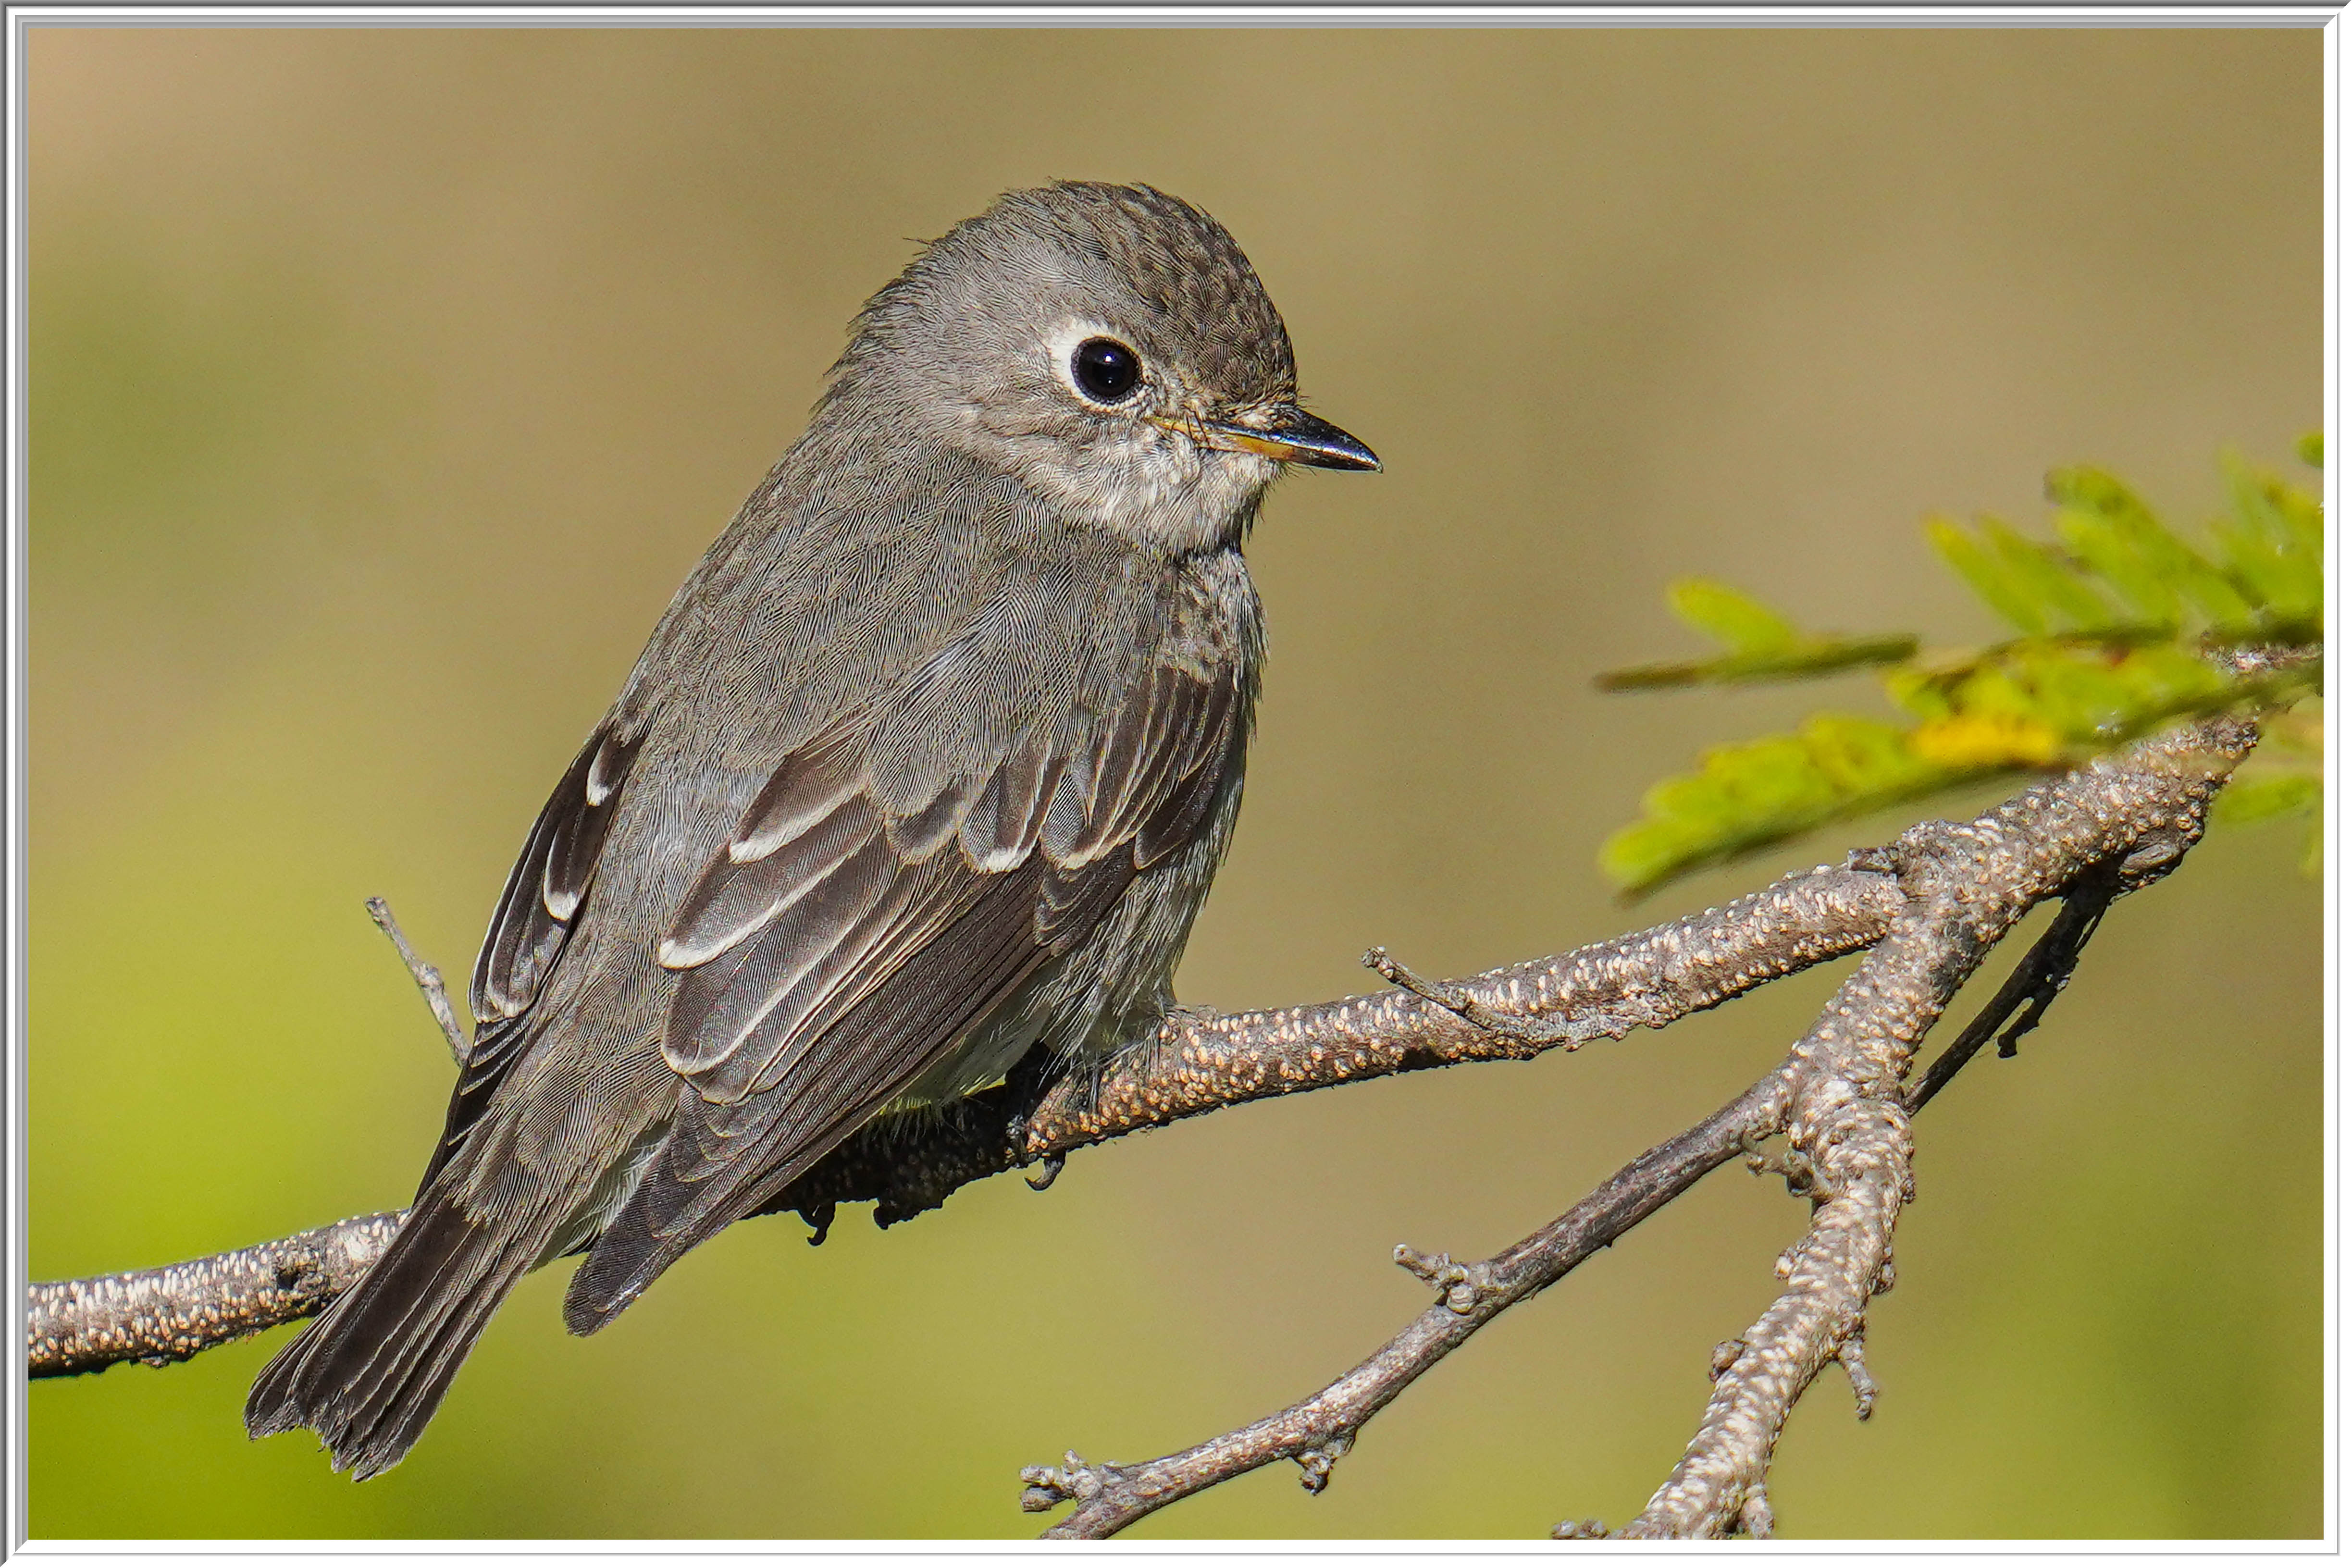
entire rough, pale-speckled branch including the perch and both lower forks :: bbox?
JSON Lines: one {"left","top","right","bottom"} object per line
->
{"left": 31, "top": 717, "right": 2258, "bottom": 1535}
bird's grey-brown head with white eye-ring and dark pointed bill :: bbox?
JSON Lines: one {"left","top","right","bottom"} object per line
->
{"left": 832, "top": 181, "right": 1381, "bottom": 553}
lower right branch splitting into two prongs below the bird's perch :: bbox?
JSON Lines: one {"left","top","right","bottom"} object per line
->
{"left": 1021, "top": 719, "right": 2255, "bottom": 1537}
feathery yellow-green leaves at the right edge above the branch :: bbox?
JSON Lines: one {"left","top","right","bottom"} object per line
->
{"left": 1599, "top": 446, "right": 2326, "bottom": 896}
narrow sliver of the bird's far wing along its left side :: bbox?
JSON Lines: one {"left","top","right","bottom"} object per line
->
{"left": 416, "top": 719, "right": 644, "bottom": 1192}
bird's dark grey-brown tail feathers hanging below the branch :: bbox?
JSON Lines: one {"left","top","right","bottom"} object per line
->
{"left": 245, "top": 1192, "right": 545, "bottom": 1481}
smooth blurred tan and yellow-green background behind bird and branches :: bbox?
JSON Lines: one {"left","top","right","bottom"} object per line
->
{"left": 28, "top": 28, "right": 2324, "bottom": 1537}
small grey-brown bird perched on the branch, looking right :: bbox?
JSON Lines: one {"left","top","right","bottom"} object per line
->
{"left": 245, "top": 181, "right": 1381, "bottom": 1479}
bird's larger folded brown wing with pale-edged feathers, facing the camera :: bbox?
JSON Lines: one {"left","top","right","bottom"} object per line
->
{"left": 567, "top": 634, "right": 1249, "bottom": 1333}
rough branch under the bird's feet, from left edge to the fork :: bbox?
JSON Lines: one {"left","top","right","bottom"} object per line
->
{"left": 28, "top": 867, "right": 1903, "bottom": 1378}
